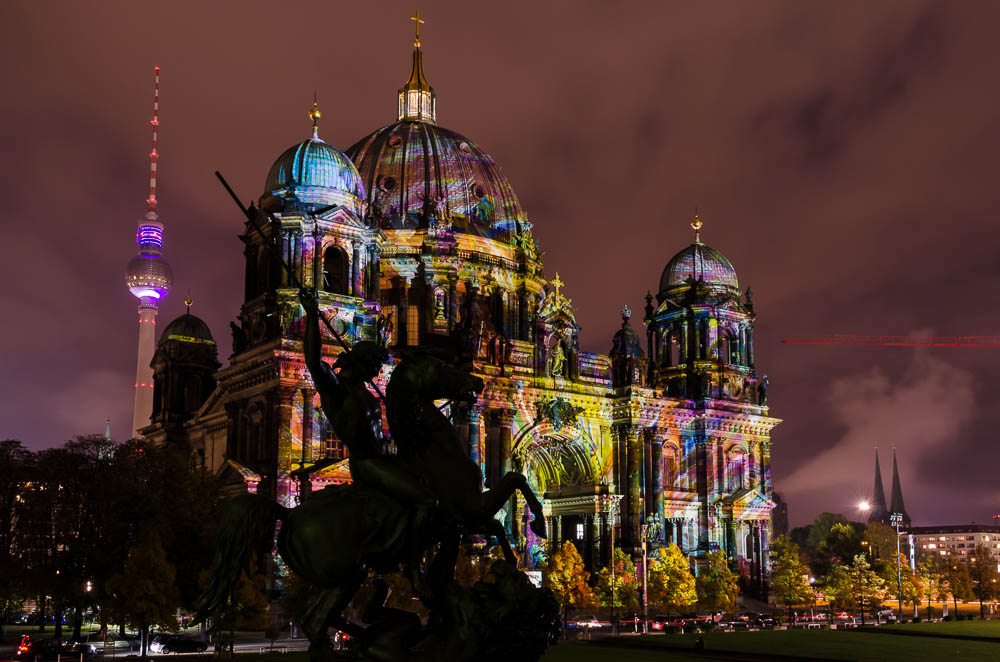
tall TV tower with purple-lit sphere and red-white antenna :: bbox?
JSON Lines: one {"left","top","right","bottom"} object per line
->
{"left": 125, "top": 67, "right": 174, "bottom": 437}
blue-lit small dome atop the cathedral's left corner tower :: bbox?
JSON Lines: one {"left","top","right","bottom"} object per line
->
{"left": 264, "top": 134, "right": 365, "bottom": 213}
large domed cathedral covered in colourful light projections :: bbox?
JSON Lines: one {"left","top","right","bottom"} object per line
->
{"left": 141, "top": 24, "right": 780, "bottom": 592}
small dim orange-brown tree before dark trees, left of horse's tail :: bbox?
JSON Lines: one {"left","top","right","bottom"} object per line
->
{"left": 108, "top": 530, "right": 180, "bottom": 658}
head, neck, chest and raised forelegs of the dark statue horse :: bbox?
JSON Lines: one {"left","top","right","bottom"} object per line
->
{"left": 386, "top": 349, "right": 545, "bottom": 563}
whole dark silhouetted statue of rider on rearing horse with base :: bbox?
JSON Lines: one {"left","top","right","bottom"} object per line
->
{"left": 198, "top": 293, "right": 559, "bottom": 662}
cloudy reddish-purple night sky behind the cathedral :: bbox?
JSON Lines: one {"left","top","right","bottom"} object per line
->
{"left": 0, "top": 0, "right": 1000, "bottom": 524}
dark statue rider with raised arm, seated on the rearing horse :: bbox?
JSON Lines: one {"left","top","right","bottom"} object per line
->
{"left": 299, "top": 291, "right": 437, "bottom": 592}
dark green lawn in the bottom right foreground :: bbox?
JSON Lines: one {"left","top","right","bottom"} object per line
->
{"left": 619, "top": 623, "right": 1000, "bottom": 662}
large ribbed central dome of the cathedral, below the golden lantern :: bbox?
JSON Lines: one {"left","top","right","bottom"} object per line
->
{"left": 347, "top": 120, "right": 530, "bottom": 236}
